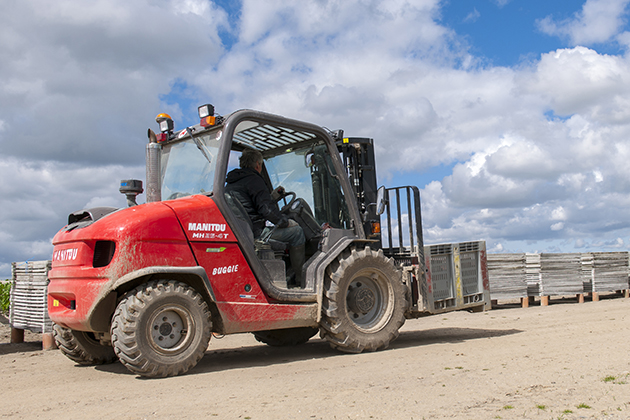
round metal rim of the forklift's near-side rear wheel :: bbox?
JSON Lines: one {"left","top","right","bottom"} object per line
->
{"left": 147, "top": 305, "right": 195, "bottom": 355}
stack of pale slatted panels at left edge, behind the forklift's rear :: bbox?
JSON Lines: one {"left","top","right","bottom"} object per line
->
{"left": 9, "top": 261, "right": 52, "bottom": 333}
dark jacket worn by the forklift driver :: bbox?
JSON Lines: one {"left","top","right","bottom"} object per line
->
{"left": 225, "top": 168, "right": 288, "bottom": 238}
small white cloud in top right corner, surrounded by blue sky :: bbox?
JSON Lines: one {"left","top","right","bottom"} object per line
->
{"left": 537, "top": 0, "right": 628, "bottom": 45}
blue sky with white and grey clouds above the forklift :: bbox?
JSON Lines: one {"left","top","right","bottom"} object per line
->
{"left": 0, "top": 0, "right": 630, "bottom": 278}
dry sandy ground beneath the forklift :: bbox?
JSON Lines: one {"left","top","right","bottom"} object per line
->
{"left": 0, "top": 297, "right": 630, "bottom": 420}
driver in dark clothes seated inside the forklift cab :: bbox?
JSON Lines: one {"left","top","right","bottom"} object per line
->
{"left": 225, "top": 149, "right": 306, "bottom": 287}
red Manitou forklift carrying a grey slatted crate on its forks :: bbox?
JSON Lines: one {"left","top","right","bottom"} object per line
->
{"left": 48, "top": 105, "right": 490, "bottom": 377}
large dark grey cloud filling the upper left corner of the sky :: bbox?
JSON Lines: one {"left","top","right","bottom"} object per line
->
{"left": 0, "top": 0, "right": 225, "bottom": 164}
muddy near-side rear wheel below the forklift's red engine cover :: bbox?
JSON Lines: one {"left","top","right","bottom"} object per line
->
{"left": 111, "top": 280, "right": 211, "bottom": 378}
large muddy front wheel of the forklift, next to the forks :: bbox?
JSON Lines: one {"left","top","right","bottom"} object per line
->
{"left": 320, "top": 247, "right": 408, "bottom": 353}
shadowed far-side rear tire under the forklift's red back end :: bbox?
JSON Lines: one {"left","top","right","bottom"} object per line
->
{"left": 53, "top": 324, "right": 117, "bottom": 366}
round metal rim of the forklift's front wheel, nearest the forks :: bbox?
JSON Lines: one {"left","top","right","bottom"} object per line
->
{"left": 346, "top": 270, "right": 392, "bottom": 331}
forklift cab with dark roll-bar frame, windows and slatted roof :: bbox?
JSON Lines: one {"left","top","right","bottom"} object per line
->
{"left": 154, "top": 110, "right": 365, "bottom": 302}
